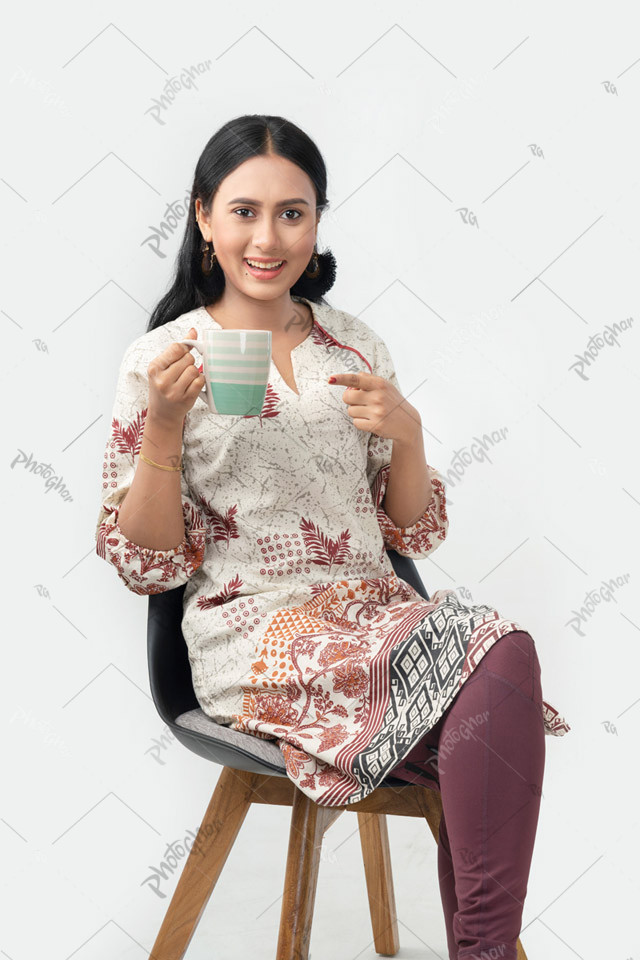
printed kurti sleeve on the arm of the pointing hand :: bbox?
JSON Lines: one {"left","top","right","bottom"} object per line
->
{"left": 367, "top": 340, "right": 449, "bottom": 560}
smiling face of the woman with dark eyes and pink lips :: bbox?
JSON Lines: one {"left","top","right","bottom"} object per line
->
{"left": 195, "top": 156, "right": 320, "bottom": 300}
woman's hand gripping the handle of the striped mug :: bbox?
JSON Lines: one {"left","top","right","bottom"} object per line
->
{"left": 147, "top": 327, "right": 206, "bottom": 423}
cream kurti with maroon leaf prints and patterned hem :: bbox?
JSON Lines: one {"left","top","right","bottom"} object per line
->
{"left": 96, "top": 300, "right": 570, "bottom": 806}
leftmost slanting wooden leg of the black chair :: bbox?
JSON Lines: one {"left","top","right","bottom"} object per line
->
{"left": 150, "top": 767, "right": 255, "bottom": 960}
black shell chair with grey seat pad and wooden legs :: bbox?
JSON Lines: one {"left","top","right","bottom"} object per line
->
{"left": 147, "top": 550, "right": 526, "bottom": 960}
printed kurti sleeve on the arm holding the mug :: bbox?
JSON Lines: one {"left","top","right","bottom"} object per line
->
{"left": 95, "top": 341, "right": 206, "bottom": 594}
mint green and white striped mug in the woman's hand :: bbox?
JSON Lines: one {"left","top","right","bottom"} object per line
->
{"left": 178, "top": 330, "right": 271, "bottom": 417}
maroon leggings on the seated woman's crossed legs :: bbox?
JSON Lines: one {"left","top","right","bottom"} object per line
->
{"left": 391, "top": 630, "right": 545, "bottom": 960}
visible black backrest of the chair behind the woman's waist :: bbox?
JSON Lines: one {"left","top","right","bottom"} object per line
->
{"left": 147, "top": 550, "right": 429, "bottom": 724}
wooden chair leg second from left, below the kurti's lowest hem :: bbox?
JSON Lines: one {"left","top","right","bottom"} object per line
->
{"left": 276, "top": 789, "right": 342, "bottom": 960}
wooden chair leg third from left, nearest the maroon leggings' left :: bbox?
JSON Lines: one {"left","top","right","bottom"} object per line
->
{"left": 358, "top": 813, "right": 400, "bottom": 957}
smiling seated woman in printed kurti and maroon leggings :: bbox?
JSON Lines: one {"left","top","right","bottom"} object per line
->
{"left": 96, "top": 115, "right": 570, "bottom": 960}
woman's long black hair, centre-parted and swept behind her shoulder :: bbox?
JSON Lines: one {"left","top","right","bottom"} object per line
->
{"left": 147, "top": 114, "right": 336, "bottom": 332}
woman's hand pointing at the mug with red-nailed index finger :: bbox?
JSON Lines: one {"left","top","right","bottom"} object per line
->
{"left": 329, "top": 373, "right": 422, "bottom": 443}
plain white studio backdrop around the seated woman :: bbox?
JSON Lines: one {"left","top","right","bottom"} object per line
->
{"left": 0, "top": 0, "right": 640, "bottom": 960}
